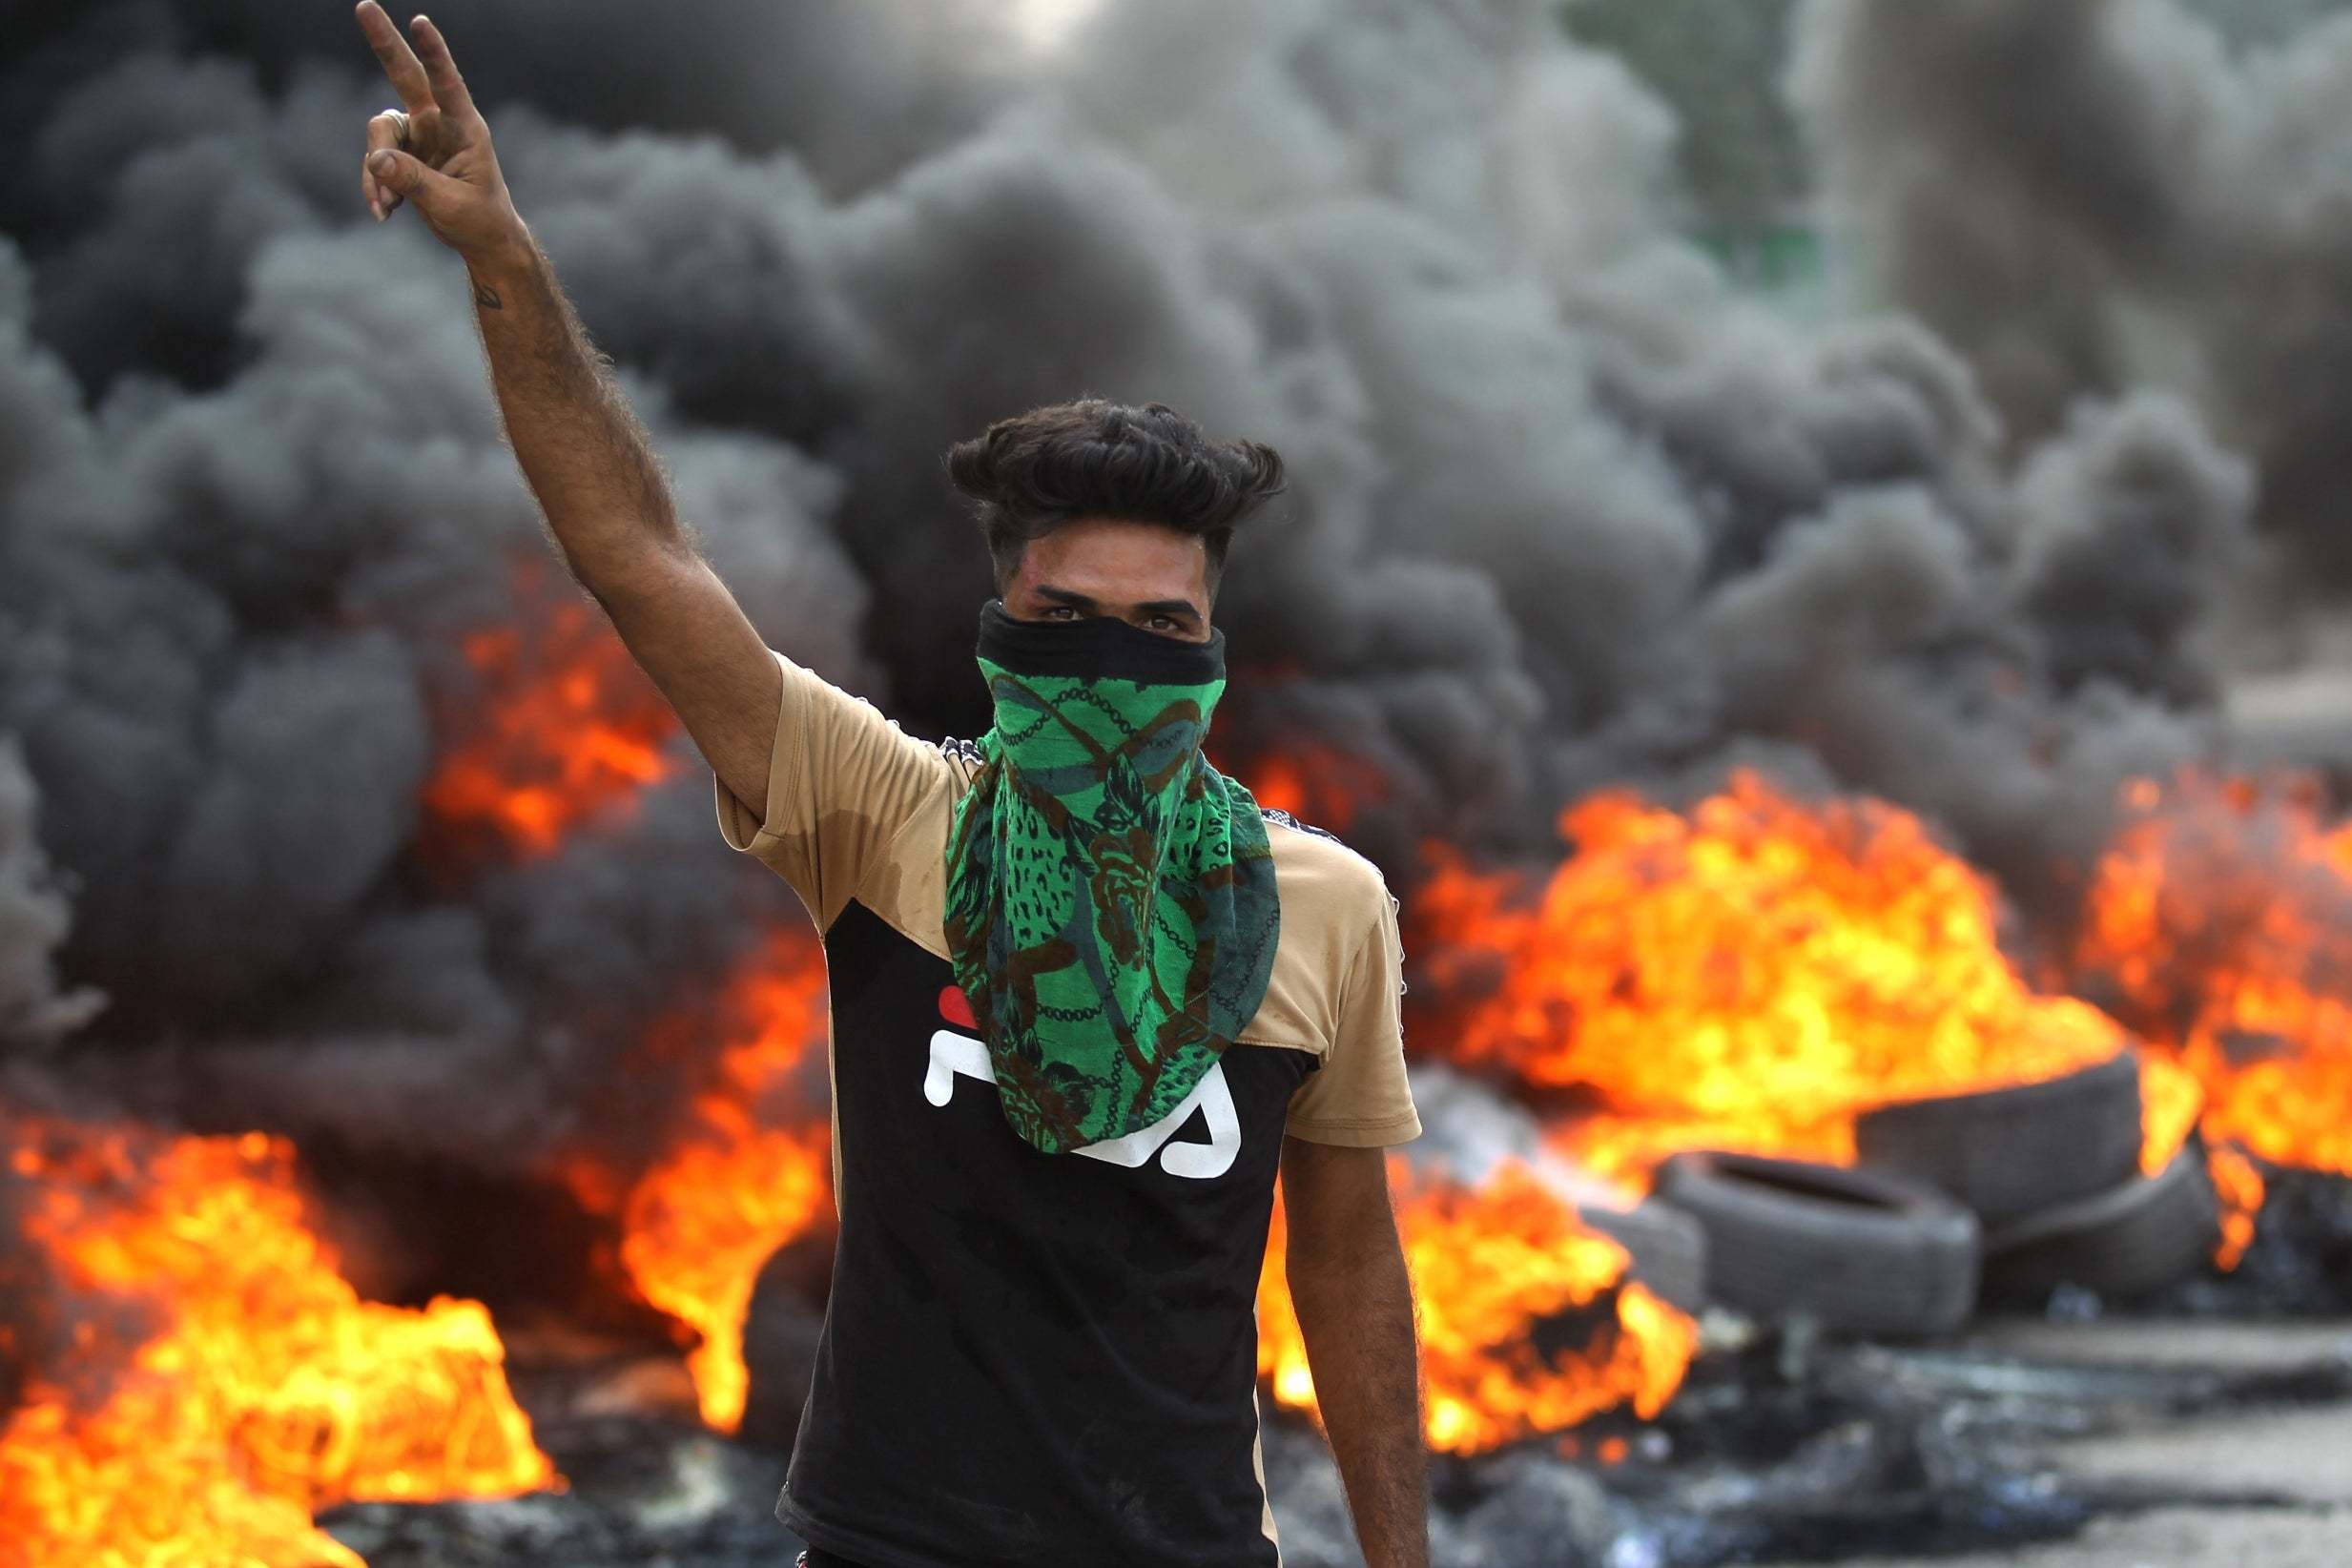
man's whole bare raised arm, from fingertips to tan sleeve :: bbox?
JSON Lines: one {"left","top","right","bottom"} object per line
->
{"left": 358, "top": 0, "right": 781, "bottom": 815}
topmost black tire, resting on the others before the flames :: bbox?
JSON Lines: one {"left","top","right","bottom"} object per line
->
{"left": 1853, "top": 1051, "right": 2143, "bottom": 1229}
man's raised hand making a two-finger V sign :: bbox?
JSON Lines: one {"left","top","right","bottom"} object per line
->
{"left": 355, "top": 0, "right": 522, "bottom": 258}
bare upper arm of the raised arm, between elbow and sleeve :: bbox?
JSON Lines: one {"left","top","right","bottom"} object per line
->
{"left": 597, "top": 547, "right": 783, "bottom": 820}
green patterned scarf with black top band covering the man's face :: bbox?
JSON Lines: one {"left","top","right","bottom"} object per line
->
{"left": 945, "top": 600, "right": 1282, "bottom": 1154}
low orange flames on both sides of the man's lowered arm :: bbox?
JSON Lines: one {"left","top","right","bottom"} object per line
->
{"left": 1258, "top": 1157, "right": 1698, "bottom": 1453}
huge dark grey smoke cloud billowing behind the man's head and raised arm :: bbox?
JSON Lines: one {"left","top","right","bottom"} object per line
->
{"left": 0, "top": 0, "right": 2251, "bottom": 1166}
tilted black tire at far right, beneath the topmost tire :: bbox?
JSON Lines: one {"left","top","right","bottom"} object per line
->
{"left": 1985, "top": 1138, "right": 2220, "bottom": 1302}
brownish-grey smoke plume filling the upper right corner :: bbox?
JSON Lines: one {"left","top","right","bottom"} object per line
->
{"left": 1790, "top": 0, "right": 2352, "bottom": 592}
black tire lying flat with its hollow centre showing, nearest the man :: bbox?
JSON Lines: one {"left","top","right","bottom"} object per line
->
{"left": 1659, "top": 1152, "right": 1980, "bottom": 1335}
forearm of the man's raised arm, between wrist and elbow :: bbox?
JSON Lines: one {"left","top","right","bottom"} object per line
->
{"left": 465, "top": 218, "right": 690, "bottom": 604}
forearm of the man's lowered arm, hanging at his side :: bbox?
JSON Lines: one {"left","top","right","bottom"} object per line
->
{"left": 1287, "top": 1236, "right": 1430, "bottom": 1568}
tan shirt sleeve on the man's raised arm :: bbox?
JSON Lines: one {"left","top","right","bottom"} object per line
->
{"left": 711, "top": 649, "right": 948, "bottom": 931}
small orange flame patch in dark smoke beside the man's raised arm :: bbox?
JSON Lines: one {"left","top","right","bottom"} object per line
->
{"left": 423, "top": 562, "right": 677, "bottom": 856}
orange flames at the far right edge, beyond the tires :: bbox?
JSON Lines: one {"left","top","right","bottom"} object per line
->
{"left": 2076, "top": 774, "right": 2352, "bottom": 1175}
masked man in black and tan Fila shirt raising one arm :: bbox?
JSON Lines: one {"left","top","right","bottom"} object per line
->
{"left": 358, "top": 0, "right": 1428, "bottom": 1568}
